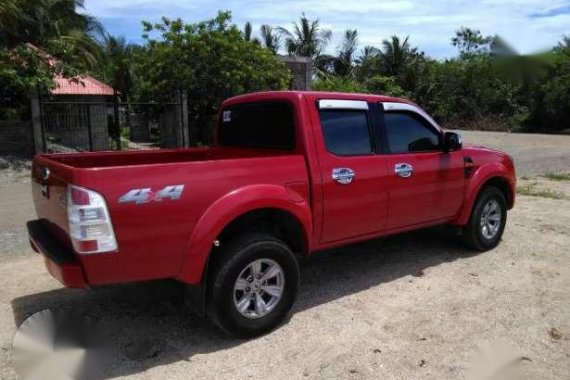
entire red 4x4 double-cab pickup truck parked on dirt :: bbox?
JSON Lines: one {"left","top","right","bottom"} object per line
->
{"left": 28, "top": 92, "right": 515, "bottom": 336}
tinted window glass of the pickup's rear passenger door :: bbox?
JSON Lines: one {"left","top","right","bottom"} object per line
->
{"left": 319, "top": 109, "right": 372, "bottom": 156}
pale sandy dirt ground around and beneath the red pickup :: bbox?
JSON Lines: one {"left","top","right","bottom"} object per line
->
{"left": 0, "top": 133, "right": 570, "bottom": 379}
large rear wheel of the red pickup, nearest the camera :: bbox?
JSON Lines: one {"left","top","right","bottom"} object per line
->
{"left": 207, "top": 233, "right": 300, "bottom": 338}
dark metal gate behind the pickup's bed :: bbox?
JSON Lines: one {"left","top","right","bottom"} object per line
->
{"left": 39, "top": 91, "right": 189, "bottom": 153}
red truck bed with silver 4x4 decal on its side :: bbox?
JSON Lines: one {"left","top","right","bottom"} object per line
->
{"left": 32, "top": 147, "right": 308, "bottom": 285}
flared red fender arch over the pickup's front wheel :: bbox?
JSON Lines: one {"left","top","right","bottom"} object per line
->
{"left": 453, "top": 162, "right": 516, "bottom": 226}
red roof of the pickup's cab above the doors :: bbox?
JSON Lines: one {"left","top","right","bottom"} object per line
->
{"left": 222, "top": 91, "right": 414, "bottom": 107}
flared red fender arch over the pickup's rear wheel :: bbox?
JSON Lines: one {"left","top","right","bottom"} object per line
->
{"left": 177, "top": 185, "right": 312, "bottom": 284}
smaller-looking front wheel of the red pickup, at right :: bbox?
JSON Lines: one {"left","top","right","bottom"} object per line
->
{"left": 463, "top": 186, "right": 507, "bottom": 251}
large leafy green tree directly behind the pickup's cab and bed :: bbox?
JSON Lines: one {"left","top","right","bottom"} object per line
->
{"left": 134, "top": 12, "right": 290, "bottom": 117}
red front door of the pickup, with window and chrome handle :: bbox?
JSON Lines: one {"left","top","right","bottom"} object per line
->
{"left": 380, "top": 103, "right": 465, "bottom": 230}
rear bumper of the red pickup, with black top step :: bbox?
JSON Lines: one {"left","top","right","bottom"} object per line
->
{"left": 27, "top": 220, "right": 87, "bottom": 288}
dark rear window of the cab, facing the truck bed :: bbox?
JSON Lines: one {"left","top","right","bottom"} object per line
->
{"left": 218, "top": 102, "right": 295, "bottom": 150}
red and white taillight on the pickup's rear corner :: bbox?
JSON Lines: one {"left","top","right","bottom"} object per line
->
{"left": 67, "top": 185, "right": 117, "bottom": 254}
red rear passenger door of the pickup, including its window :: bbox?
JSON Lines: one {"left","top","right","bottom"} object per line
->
{"left": 314, "top": 100, "right": 388, "bottom": 243}
